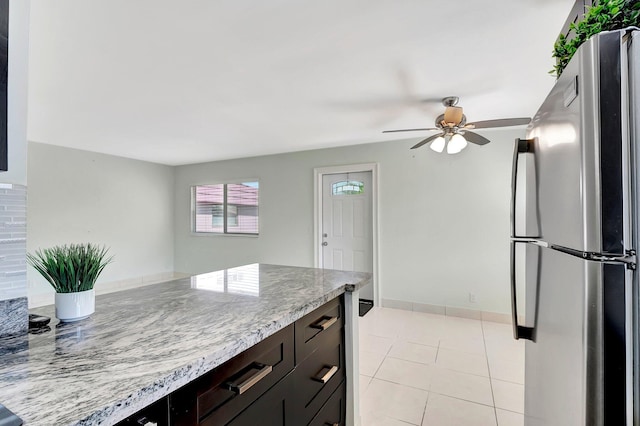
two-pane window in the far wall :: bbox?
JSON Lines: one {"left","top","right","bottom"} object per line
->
{"left": 192, "top": 182, "right": 260, "bottom": 235}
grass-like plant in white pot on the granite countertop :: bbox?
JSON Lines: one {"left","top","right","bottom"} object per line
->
{"left": 27, "top": 243, "right": 113, "bottom": 322}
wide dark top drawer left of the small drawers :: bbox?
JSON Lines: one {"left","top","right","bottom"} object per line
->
{"left": 170, "top": 326, "right": 294, "bottom": 426}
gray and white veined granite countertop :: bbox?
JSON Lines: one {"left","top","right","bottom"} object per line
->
{"left": 0, "top": 264, "right": 370, "bottom": 426}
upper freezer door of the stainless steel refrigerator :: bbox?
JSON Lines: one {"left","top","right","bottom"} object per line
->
{"left": 527, "top": 32, "right": 623, "bottom": 253}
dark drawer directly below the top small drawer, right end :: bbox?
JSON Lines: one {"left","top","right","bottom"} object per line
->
{"left": 293, "top": 328, "right": 345, "bottom": 424}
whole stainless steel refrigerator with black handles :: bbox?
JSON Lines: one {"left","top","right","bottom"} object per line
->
{"left": 511, "top": 29, "right": 640, "bottom": 426}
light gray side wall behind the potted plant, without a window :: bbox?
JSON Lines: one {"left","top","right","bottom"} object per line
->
{"left": 27, "top": 142, "right": 174, "bottom": 305}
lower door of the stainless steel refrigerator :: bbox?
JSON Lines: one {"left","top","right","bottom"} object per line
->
{"left": 525, "top": 246, "right": 632, "bottom": 426}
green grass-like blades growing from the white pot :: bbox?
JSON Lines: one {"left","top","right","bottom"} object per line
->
{"left": 27, "top": 243, "right": 113, "bottom": 293}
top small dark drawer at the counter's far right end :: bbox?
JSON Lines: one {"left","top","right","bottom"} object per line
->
{"left": 295, "top": 296, "right": 344, "bottom": 365}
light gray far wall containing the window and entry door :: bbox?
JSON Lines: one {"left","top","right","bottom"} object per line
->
{"left": 175, "top": 129, "right": 524, "bottom": 313}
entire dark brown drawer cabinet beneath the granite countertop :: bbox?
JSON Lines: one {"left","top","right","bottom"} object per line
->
{"left": 119, "top": 296, "right": 346, "bottom": 426}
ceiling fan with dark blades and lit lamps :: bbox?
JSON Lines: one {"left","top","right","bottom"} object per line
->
{"left": 382, "top": 96, "right": 531, "bottom": 154}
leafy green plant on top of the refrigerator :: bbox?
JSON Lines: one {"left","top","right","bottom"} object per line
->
{"left": 549, "top": 0, "right": 640, "bottom": 77}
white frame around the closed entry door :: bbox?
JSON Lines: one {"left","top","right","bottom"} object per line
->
{"left": 313, "top": 163, "right": 380, "bottom": 306}
